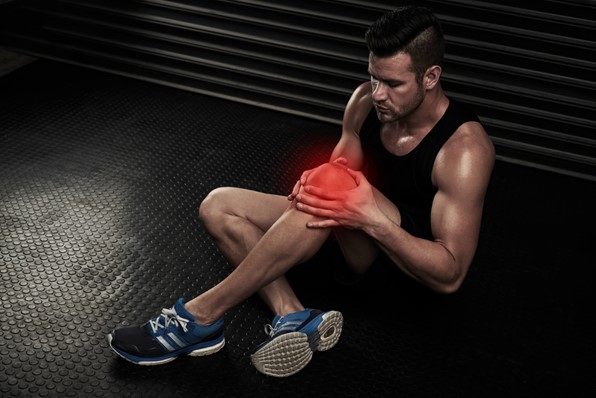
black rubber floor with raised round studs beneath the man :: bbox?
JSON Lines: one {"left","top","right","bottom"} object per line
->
{"left": 0, "top": 61, "right": 596, "bottom": 397}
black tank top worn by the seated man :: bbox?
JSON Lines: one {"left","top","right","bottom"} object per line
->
{"left": 360, "top": 99, "right": 479, "bottom": 240}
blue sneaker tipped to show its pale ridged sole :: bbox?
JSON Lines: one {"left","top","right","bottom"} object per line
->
{"left": 250, "top": 308, "right": 343, "bottom": 377}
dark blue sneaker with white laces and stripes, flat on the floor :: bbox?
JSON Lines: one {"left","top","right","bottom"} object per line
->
{"left": 108, "top": 299, "right": 225, "bottom": 365}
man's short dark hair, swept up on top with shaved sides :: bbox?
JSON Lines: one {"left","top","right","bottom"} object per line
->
{"left": 365, "top": 6, "right": 445, "bottom": 76}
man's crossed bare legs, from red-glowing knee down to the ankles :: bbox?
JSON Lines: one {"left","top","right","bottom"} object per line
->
{"left": 186, "top": 163, "right": 392, "bottom": 324}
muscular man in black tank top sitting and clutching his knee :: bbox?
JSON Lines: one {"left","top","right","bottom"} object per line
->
{"left": 109, "top": 7, "right": 495, "bottom": 377}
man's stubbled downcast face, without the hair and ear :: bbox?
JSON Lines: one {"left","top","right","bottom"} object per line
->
{"left": 368, "top": 53, "right": 426, "bottom": 123}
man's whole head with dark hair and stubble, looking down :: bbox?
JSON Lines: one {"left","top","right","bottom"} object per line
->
{"left": 365, "top": 6, "right": 445, "bottom": 123}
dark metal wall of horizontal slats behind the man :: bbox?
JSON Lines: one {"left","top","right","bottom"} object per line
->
{"left": 0, "top": 0, "right": 596, "bottom": 181}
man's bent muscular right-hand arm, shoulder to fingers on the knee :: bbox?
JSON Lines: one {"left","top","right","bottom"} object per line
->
{"left": 298, "top": 119, "right": 494, "bottom": 293}
